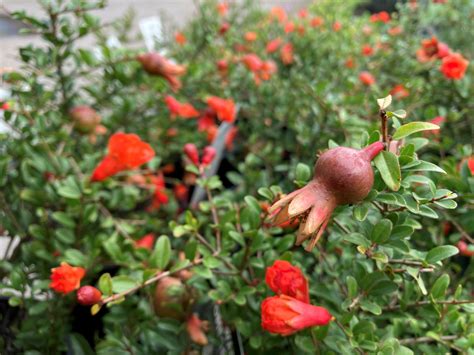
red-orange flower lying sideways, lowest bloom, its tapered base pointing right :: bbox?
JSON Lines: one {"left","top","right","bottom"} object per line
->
{"left": 261, "top": 295, "right": 333, "bottom": 336}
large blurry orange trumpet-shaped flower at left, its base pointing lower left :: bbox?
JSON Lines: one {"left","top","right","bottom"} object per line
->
{"left": 91, "top": 132, "right": 155, "bottom": 181}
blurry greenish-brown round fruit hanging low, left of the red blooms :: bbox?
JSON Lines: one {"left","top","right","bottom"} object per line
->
{"left": 154, "top": 277, "right": 191, "bottom": 320}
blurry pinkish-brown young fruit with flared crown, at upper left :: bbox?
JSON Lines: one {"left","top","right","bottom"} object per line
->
{"left": 137, "top": 52, "right": 186, "bottom": 91}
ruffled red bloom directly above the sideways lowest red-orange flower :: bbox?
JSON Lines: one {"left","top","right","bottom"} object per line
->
{"left": 265, "top": 260, "right": 309, "bottom": 303}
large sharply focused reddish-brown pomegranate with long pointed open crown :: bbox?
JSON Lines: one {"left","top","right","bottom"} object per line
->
{"left": 269, "top": 142, "right": 384, "bottom": 251}
